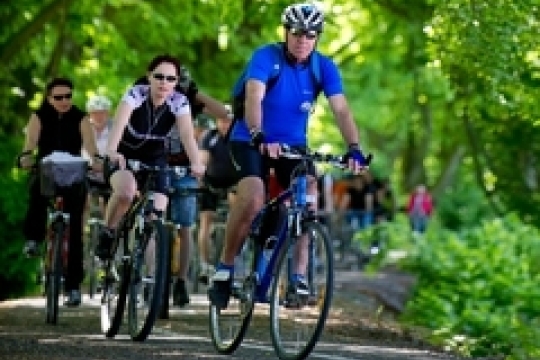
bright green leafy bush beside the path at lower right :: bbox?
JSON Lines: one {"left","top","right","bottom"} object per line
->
{"left": 402, "top": 216, "right": 540, "bottom": 359}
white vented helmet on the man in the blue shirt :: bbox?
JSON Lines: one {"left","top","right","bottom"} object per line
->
{"left": 281, "top": 3, "right": 324, "bottom": 33}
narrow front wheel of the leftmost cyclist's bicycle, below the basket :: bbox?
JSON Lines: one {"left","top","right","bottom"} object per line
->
{"left": 46, "top": 222, "right": 65, "bottom": 325}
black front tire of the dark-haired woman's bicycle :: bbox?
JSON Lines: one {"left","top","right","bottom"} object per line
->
{"left": 128, "top": 220, "right": 170, "bottom": 341}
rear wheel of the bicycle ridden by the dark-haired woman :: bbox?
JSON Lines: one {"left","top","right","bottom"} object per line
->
{"left": 100, "top": 234, "right": 131, "bottom": 338}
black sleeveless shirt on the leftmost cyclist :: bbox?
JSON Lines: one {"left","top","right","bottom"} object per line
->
{"left": 36, "top": 102, "right": 86, "bottom": 159}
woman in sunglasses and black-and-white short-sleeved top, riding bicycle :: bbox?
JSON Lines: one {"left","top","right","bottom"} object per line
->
{"left": 96, "top": 55, "right": 204, "bottom": 259}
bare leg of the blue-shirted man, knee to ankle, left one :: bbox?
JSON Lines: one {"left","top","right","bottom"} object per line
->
{"left": 221, "top": 176, "right": 265, "bottom": 266}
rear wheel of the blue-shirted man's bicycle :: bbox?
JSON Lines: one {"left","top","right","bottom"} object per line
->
{"left": 209, "top": 238, "right": 257, "bottom": 354}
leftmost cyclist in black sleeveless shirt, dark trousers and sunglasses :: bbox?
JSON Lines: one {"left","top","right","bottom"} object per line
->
{"left": 18, "top": 78, "right": 99, "bottom": 306}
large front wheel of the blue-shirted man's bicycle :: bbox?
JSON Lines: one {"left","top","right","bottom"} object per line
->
{"left": 270, "top": 222, "right": 334, "bottom": 360}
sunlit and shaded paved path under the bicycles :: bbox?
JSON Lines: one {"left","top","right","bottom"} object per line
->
{"left": 0, "top": 275, "right": 464, "bottom": 360}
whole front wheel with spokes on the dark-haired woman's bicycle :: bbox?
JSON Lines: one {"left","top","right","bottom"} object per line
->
{"left": 128, "top": 220, "right": 170, "bottom": 341}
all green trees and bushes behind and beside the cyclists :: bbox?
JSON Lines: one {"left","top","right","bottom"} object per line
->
{"left": 0, "top": 7, "right": 540, "bottom": 358}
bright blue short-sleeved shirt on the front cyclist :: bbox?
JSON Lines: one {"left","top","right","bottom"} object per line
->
{"left": 230, "top": 44, "right": 343, "bottom": 146}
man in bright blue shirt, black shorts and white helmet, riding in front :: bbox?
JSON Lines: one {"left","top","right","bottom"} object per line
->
{"left": 208, "top": 3, "right": 368, "bottom": 308}
